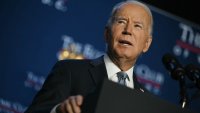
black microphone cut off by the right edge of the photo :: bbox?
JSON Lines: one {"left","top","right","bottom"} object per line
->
{"left": 185, "top": 64, "right": 200, "bottom": 89}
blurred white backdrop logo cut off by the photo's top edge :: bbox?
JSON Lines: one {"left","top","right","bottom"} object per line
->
{"left": 41, "top": 0, "right": 68, "bottom": 12}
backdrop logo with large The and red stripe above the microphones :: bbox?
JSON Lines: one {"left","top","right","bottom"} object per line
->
{"left": 173, "top": 23, "right": 200, "bottom": 64}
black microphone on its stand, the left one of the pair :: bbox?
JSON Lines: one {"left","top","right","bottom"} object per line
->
{"left": 162, "top": 53, "right": 188, "bottom": 108}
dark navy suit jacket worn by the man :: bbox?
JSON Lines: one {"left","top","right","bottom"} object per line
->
{"left": 25, "top": 57, "right": 147, "bottom": 113}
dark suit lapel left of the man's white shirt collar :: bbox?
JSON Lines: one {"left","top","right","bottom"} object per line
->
{"left": 89, "top": 56, "right": 108, "bottom": 86}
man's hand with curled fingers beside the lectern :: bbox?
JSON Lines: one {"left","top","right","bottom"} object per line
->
{"left": 56, "top": 95, "right": 83, "bottom": 113}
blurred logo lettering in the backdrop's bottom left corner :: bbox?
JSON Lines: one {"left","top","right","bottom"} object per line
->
{"left": 0, "top": 98, "right": 27, "bottom": 113}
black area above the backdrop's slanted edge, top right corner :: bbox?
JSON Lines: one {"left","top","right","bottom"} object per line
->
{"left": 140, "top": 0, "right": 200, "bottom": 25}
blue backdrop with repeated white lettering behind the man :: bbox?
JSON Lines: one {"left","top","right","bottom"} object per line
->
{"left": 0, "top": 0, "right": 200, "bottom": 113}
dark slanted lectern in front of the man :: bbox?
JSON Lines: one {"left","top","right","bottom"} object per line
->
{"left": 90, "top": 79, "right": 194, "bottom": 113}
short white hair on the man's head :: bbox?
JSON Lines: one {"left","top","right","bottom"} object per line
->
{"left": 107, "top": 0, "right": 153, "bottom": 35}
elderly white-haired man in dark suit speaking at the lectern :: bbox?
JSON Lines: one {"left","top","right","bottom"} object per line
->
{"left": 26, "top": 1, "right": 153, "bottom": 113}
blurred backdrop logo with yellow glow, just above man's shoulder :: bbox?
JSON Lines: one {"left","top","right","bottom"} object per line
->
{"left": 57, "top": 35, "right": 103, "bottom": 60}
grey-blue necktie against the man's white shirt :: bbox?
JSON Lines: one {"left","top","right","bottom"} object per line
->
{"left": 117, "top": 71, "right": 129, "bottom": 86}
